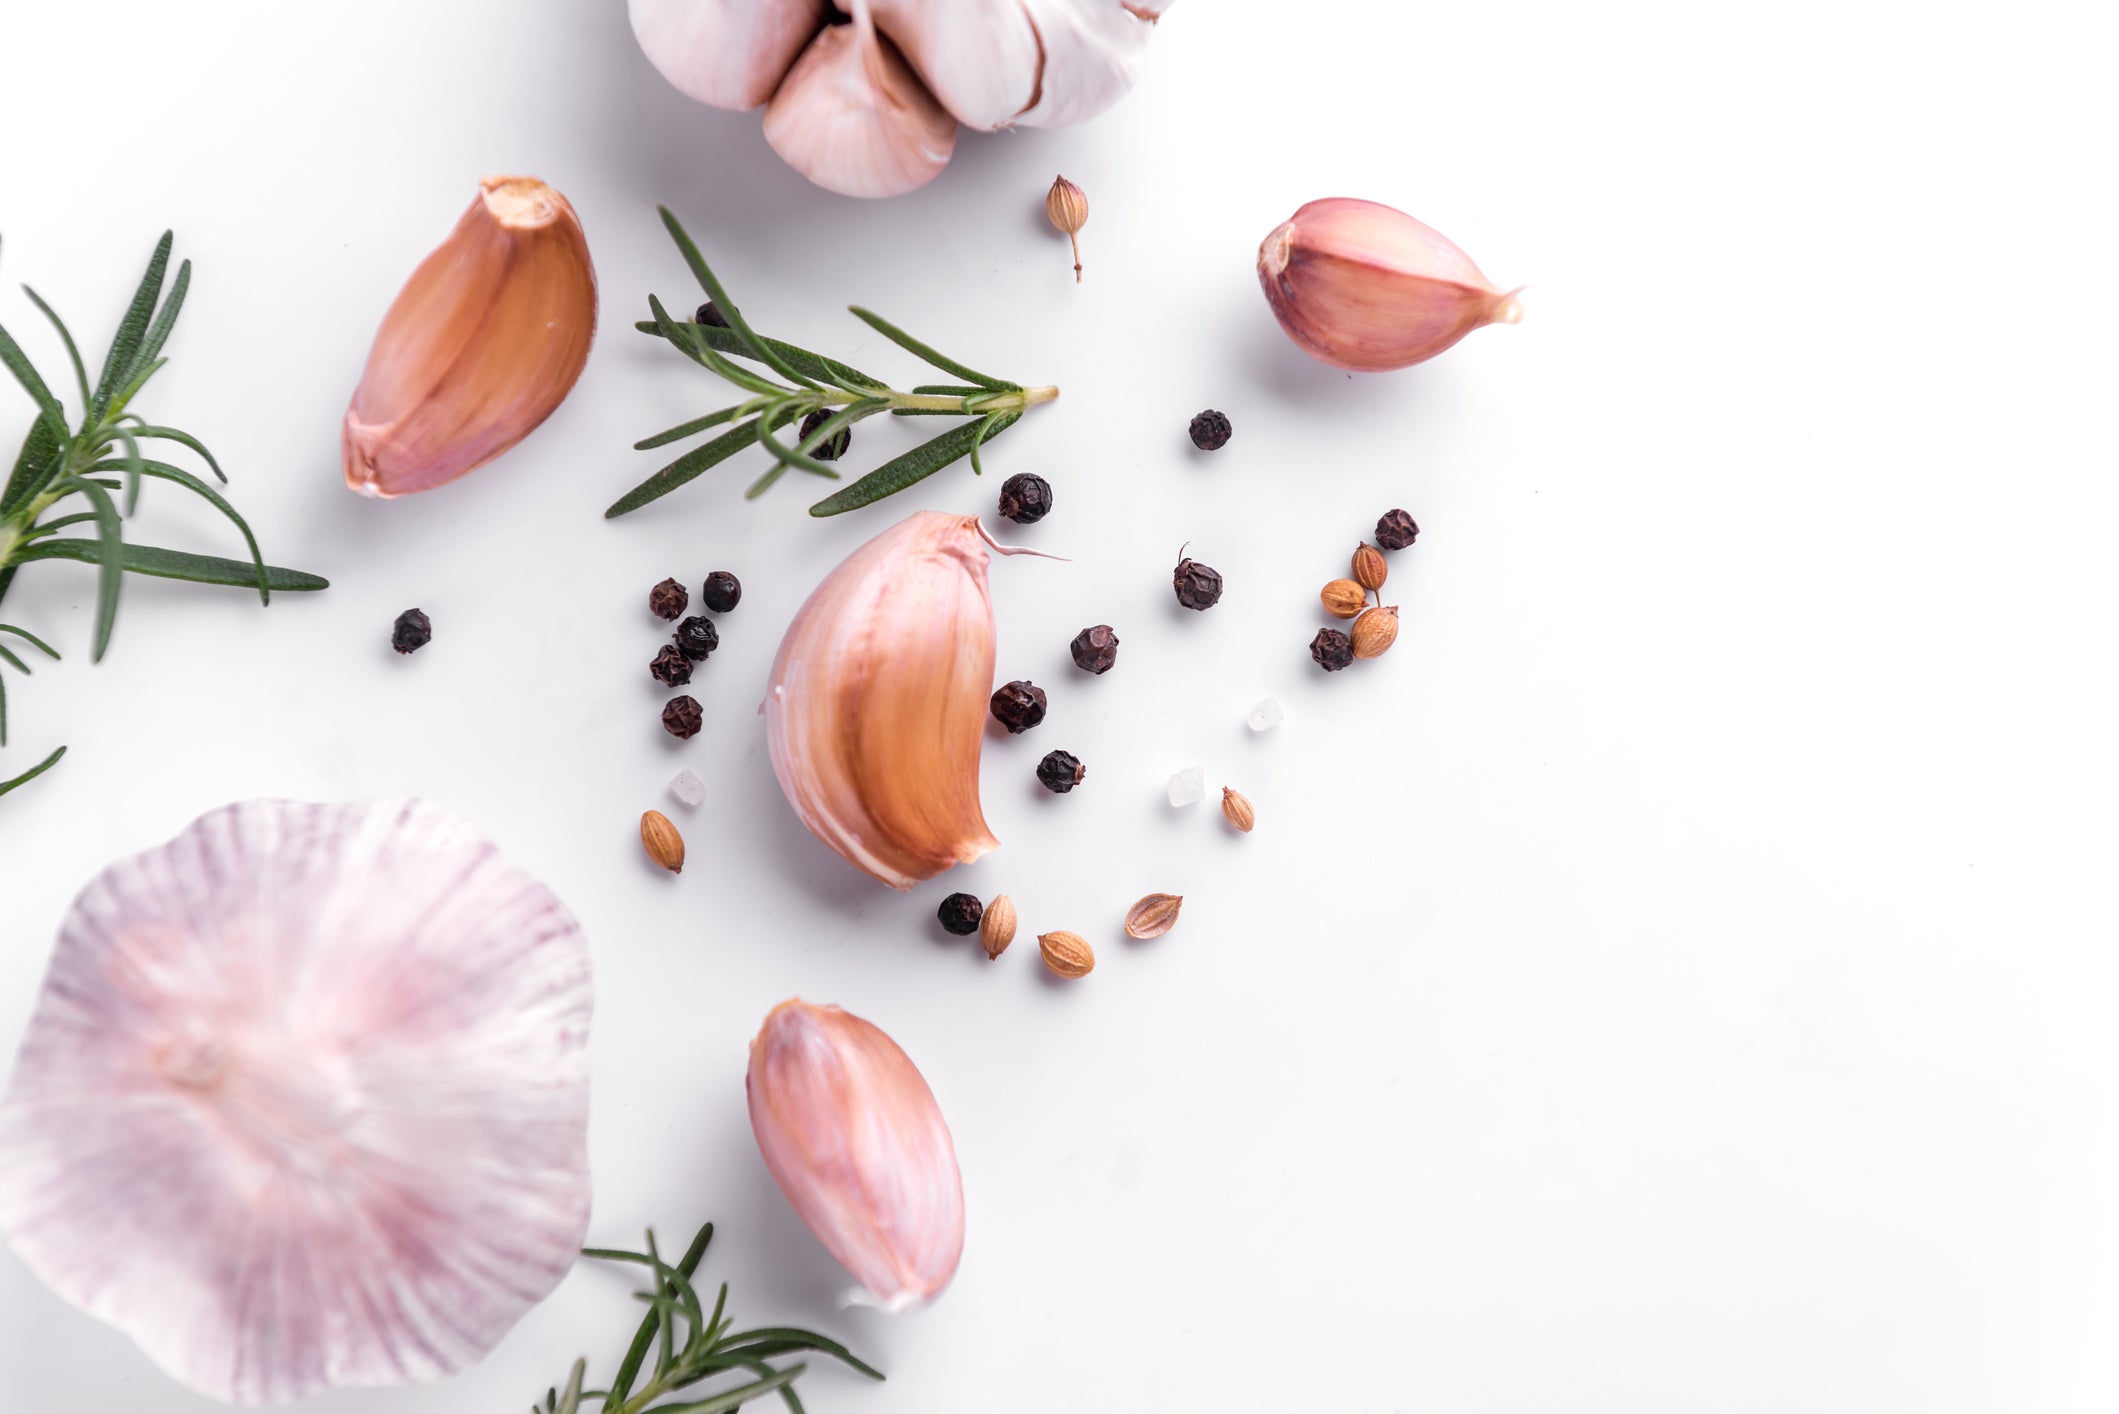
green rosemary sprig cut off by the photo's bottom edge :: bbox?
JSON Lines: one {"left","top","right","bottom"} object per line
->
{"left": 546, "top": 1223, "right": 884, "bottom": 1414}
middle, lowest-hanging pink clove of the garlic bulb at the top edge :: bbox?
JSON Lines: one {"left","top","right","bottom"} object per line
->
{"left": 765, "top": 0, "right": 956, "bottom": 197}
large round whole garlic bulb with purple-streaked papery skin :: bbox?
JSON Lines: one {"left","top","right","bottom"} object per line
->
{"left": 0, "top": 801, "right": 589, "bottom": 1408}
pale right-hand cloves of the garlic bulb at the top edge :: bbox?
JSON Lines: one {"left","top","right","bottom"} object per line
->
{"left": 873, "top": 0, "right": 1170, "bottom": 131}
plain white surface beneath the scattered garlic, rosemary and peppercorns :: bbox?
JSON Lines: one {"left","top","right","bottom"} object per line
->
{"left": 0, "top": 0, "right": 2119, "bottom": 1414}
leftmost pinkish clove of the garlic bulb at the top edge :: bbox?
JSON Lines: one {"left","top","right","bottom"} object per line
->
{"left": 625, "top": 0, "right": 826, "bottom": 108}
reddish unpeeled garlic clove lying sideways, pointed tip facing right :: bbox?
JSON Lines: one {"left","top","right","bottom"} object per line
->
{"left": 1259, "top": 197, "right": 1521, "bottom": 373}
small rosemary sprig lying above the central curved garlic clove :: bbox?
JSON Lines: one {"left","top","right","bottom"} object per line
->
{"left": 604, "top": 206, "right": 1060, "bottom": 517}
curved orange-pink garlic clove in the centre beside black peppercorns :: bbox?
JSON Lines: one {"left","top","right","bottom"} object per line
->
{"left": 765, "top": 511, "right": 1000, "bottom": 888}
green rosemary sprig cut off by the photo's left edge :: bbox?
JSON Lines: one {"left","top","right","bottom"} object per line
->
{"left": 0, "top": 231, "right": 328, "bottom": 795}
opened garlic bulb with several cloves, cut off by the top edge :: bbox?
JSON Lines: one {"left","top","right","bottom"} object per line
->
{"left": 627, "top": 0, "right": 1170, "bottom": 195}
